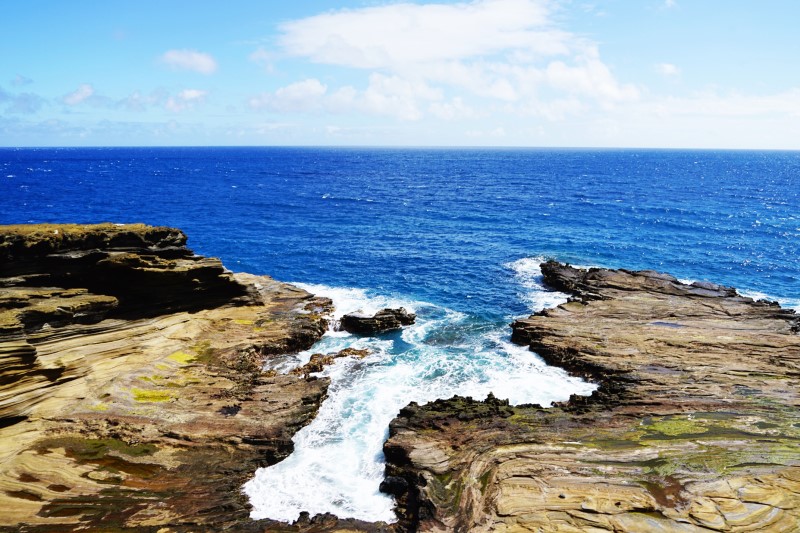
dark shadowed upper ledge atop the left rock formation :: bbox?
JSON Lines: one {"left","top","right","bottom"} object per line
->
{"left": 0, "top": 220, "right": 255, "bottom": 320}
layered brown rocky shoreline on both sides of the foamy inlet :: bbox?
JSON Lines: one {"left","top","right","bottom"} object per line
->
{"left": 0, "top": 224, "right": 800, "bottom": 532}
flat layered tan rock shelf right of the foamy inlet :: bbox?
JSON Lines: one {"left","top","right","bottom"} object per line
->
{"left": 383, "top": 262, "right": 800, "bottom": 532}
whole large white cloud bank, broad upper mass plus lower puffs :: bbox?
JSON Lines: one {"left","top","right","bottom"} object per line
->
{"left": 260, "top": 0, "right": 640, "bottom": 120}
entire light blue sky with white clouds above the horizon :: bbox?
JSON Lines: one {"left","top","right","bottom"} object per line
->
{"left": 0, "top": 0, "right": 800, "bottom": 150}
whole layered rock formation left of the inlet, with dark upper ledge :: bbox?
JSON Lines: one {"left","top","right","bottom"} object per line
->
{"left": 0, "top": 224, "right": 340, "bottom": 531}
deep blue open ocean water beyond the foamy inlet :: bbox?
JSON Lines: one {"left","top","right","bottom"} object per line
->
{"left": 0, "top": 148, "right": 800, "bottom": 316}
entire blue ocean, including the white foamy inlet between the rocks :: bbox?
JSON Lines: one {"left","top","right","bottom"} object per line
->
{"left": 0, "top": 147, "right": 800, "bottom": 521}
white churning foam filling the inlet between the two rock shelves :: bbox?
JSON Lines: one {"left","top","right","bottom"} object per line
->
{"left": 243, "top": 285, "right": 595, "bottom": 522}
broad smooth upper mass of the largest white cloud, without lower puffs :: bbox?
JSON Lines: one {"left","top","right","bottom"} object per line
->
{"left": 280, "top": 0, "right": 556, "bottom": 69}
